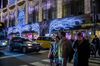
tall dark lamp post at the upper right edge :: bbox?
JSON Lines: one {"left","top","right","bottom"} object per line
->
{"left": 92, "top": 0, "right": 96, "bottom": 35}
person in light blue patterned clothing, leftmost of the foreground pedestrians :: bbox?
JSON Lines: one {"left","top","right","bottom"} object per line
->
{"left": 48, "top": 36, "right": 60, "bottom": 66}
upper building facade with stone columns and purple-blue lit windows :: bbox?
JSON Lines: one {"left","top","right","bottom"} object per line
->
{"left": 0, "top": 0, "right": 100, "bottom": 37}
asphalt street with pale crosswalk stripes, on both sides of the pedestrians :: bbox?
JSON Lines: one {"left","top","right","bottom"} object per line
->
{"left": 0, "top": 50, "right": 100, "bottom": 66}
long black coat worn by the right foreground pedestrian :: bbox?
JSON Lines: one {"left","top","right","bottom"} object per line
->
{"left": 73, "top": 39, "right": 90, "bottom": 66}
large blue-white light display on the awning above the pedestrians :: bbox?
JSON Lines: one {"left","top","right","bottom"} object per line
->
{"left": 49, "top": 17, "right": 83, "bottom": 34}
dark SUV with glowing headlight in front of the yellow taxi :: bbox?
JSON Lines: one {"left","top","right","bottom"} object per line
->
{"left": 9, "top": 37, "right": 41, "bottom": 53}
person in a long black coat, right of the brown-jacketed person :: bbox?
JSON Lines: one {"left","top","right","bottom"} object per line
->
{"left": 73, "top": 32, "right": 90, "bottom": 66}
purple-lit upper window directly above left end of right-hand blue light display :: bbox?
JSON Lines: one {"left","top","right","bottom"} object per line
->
{"left": 42, "top": 0, "right": 57, "bottom": 20}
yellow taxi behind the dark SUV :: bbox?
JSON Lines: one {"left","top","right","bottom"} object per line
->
{"left": 36, "top": 36, "right": 53, "bottom": 49}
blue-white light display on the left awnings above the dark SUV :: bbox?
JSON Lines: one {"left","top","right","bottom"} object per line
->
{"left": 8, "top": 23, "right": 40, "bottom": 34}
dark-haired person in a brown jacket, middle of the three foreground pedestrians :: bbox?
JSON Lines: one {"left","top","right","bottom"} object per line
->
{"left": 58, "top": 32, "right": 71, "bottom": 66}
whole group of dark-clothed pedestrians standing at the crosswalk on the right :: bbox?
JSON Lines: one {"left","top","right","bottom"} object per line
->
{"left": 48, "top": 31, "right": 100, "bottom": 66}
